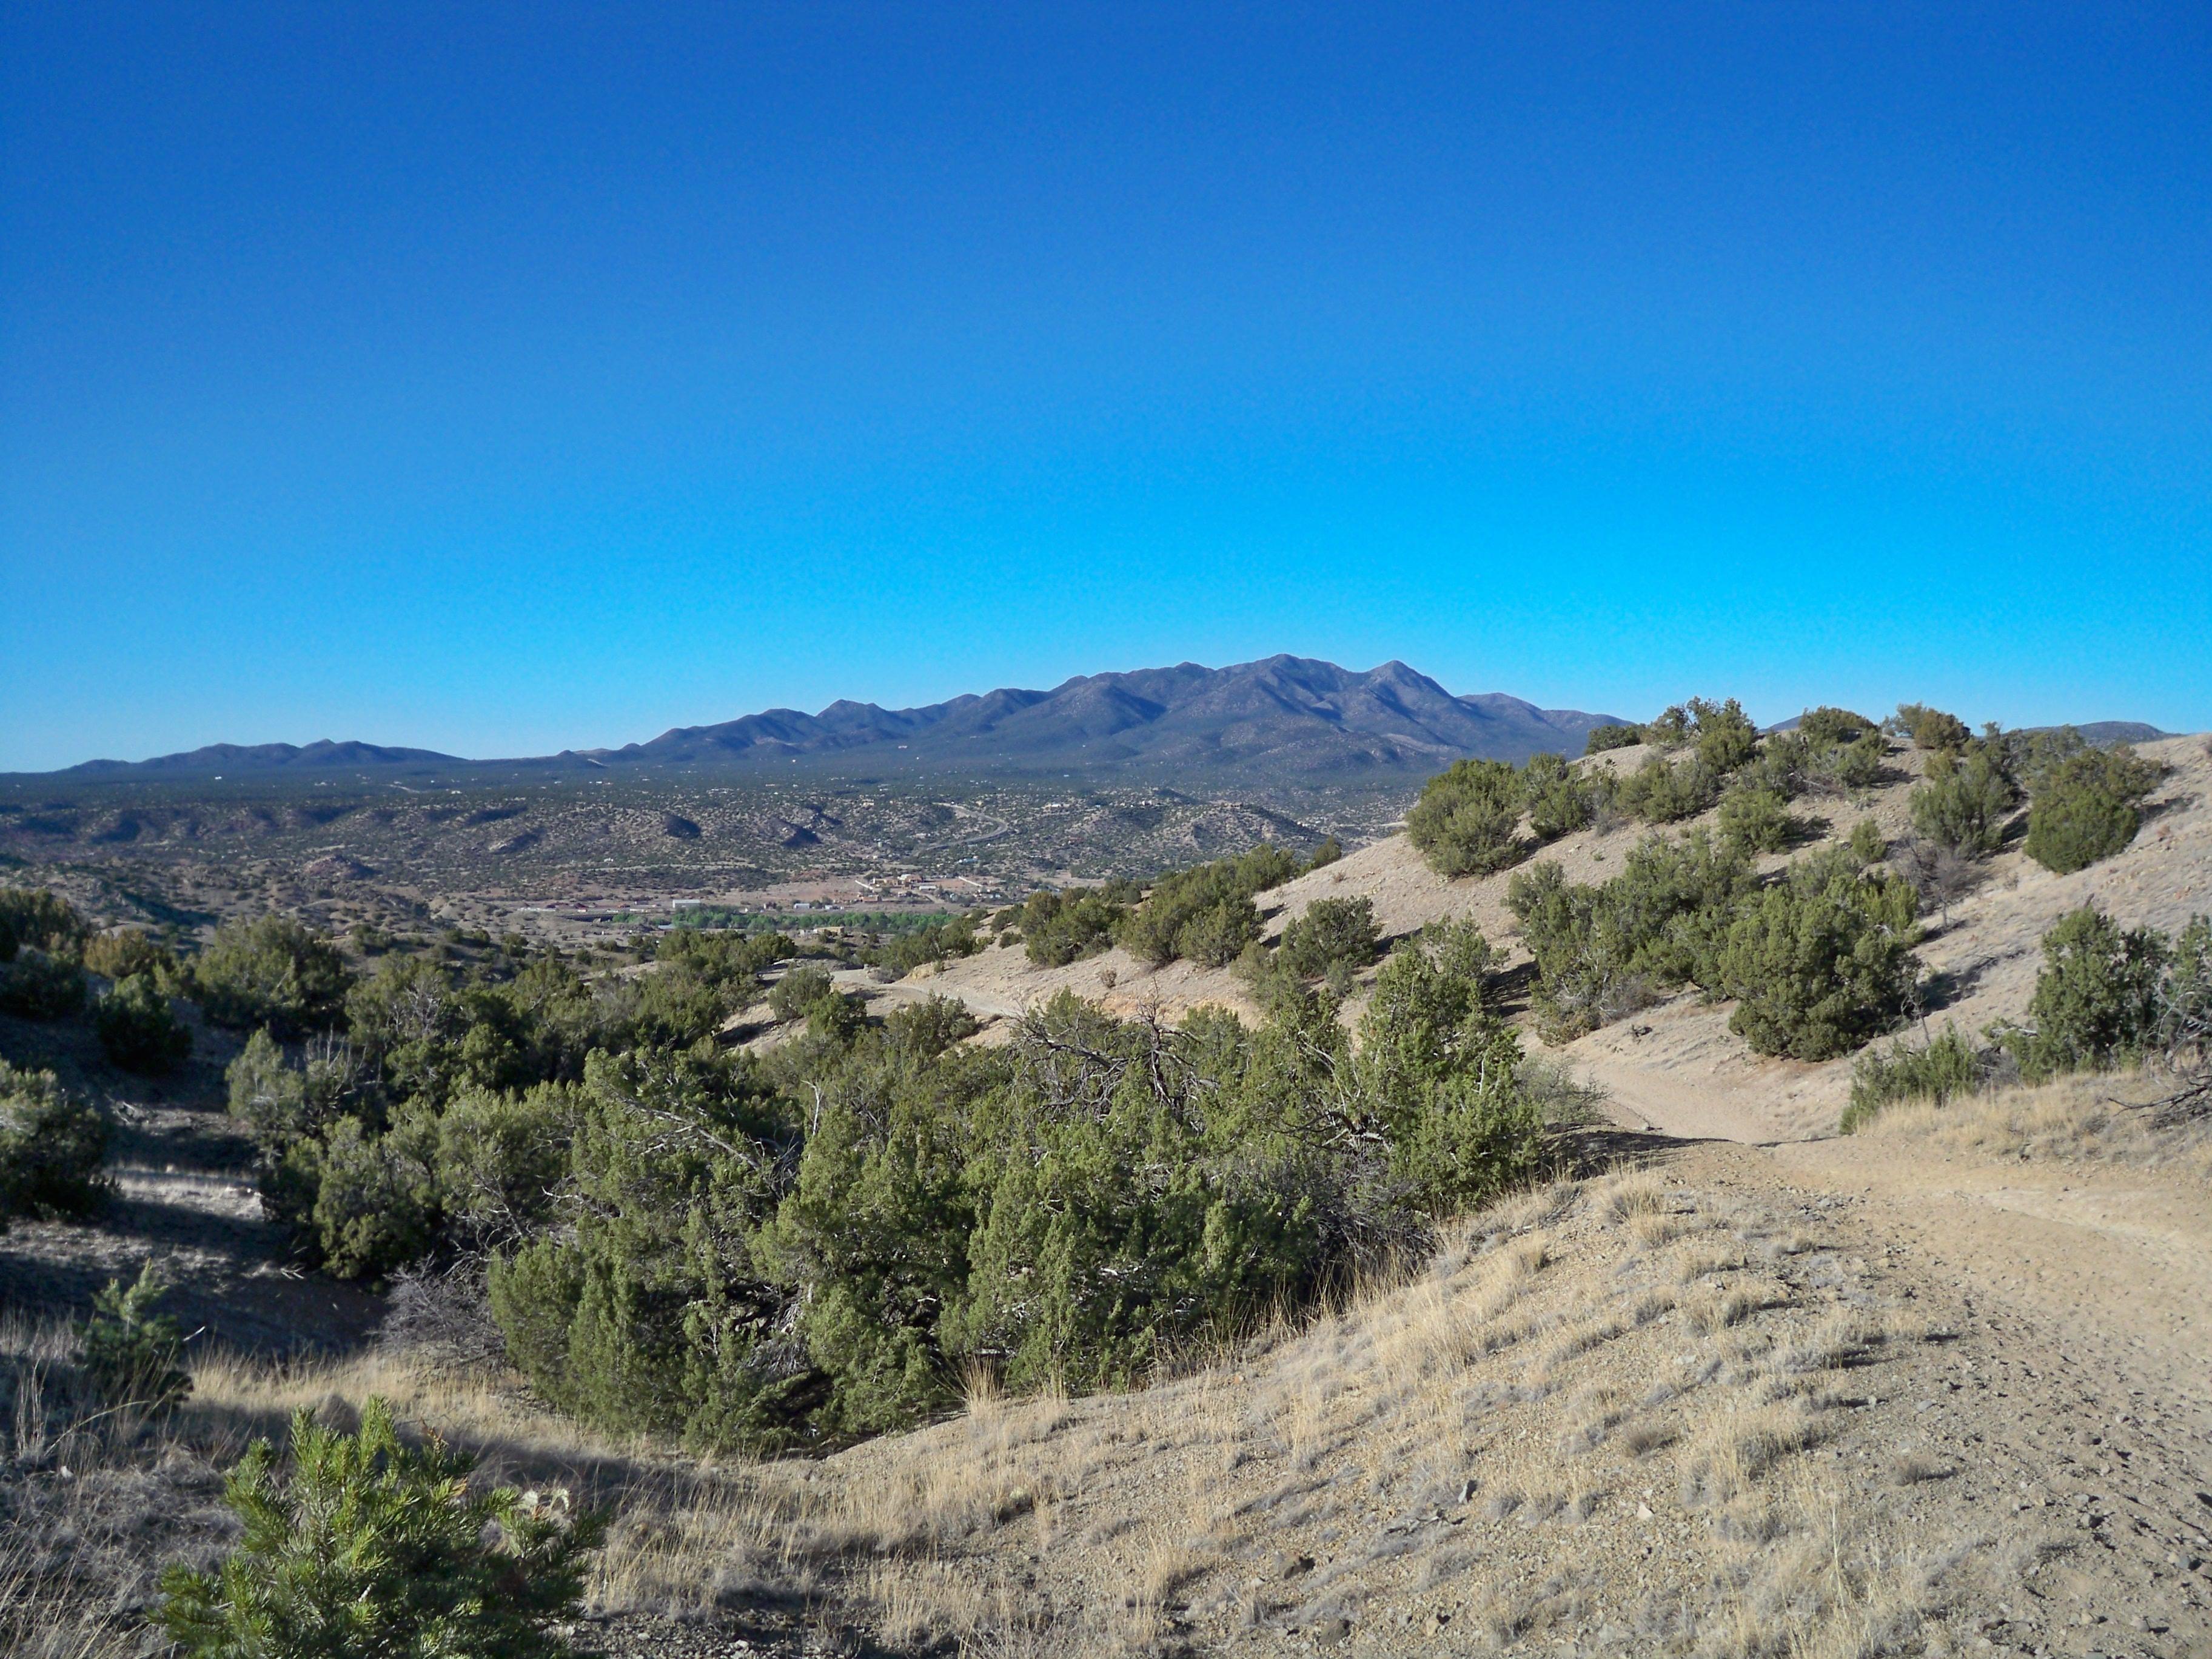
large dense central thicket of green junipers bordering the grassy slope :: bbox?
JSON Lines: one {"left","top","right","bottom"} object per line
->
{"left": 491, "top": 929, "right": 1542, "bottom": 1449}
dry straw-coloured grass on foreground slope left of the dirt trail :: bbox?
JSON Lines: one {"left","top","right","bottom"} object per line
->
{"left": 0, "top": 1172, "right": 2026, "bottom": 1659}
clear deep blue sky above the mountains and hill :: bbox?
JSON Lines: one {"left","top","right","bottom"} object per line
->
{"left": 0, "top": 0, "right": 2212, "bottom": 768}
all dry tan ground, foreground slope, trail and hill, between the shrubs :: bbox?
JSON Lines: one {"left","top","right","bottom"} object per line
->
{"left": 0, "top": 739, "right": 2212, "bottom": 1659}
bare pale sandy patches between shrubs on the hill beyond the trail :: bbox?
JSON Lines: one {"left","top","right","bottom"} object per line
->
{"left": 891, "top": 737, "right": 2212, "bottom": 1141}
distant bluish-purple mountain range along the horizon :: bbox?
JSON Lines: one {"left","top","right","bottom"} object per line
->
{"left": 52, "top": 657, "right": 1615, "bottom": 783}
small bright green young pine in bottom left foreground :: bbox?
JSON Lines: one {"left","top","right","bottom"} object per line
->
{"left": 159, "top": 1398, "right": 606, "bottom": 1659}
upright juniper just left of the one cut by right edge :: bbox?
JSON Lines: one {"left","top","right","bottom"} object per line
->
{"left": 1997, "top": 905, "right": 2168, "bottom": 1082}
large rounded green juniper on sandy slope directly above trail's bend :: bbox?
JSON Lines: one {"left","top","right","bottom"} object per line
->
{"left": 1717, "top": 847, "right": 1920, "bottom": 1059}
